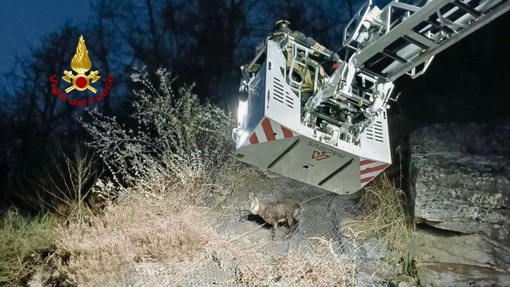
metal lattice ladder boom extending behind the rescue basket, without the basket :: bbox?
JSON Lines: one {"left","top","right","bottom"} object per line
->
{"left": 343, "top": 0, "right": 510, "bottom": 82}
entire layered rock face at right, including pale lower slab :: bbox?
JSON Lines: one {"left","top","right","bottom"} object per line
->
{"left": 410, "top": 122, "right": 510, "bottom": 286}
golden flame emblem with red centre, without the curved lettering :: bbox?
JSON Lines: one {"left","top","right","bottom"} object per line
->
{"left": 62, "top": 35, "right": 101, "bottom": 94}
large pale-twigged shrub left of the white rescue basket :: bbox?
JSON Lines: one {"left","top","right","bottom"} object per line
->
{"left": 84, "top": 69, "right": 235, "bottom": 202}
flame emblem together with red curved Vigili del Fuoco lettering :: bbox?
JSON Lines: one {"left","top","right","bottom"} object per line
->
{"left": 50, "top": 36, "right": 113, "bottom": 107}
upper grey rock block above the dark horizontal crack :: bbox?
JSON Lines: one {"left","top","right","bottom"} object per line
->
{"left": 411, "top": 124, "right": 510, "bottom": 242}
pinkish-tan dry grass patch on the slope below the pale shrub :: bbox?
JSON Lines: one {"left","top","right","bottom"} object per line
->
{"left": 53, "top": 199, "right": 216, "bottom": 286}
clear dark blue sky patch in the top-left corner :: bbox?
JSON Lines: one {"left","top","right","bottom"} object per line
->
{"left": 0, "top": 0, "right": 92, "bottom": 76}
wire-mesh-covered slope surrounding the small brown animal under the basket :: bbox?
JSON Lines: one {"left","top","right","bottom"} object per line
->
{"left": 119, "top": 174, "right": 400, "bottom": 286}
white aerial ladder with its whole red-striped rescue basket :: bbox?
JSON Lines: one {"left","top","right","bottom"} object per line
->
{"left": 233, "top": 0, "right": 510, "bottom": 194}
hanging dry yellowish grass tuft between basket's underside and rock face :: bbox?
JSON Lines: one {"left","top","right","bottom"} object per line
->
{"left": 342, "top": 174, "right": 412, "bottom": 272}
